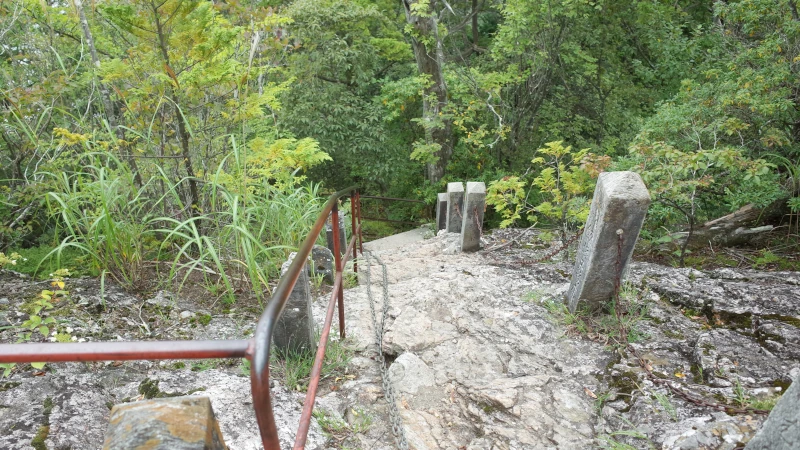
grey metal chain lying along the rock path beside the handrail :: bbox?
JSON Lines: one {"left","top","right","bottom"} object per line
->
{"left": 364, "top": 252, "right": 408, "bottom": 450}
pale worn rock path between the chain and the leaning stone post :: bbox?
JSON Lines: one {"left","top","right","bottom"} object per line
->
{"left": 312, "top": 235, "right": 610, "bottom": 450}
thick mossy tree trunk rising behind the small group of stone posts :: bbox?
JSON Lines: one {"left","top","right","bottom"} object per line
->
{"left": 403, "top": 0, "right": 453, "bottom": 183}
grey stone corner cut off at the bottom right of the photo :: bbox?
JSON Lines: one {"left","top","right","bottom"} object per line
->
{"left": 745, "top": 378, "right": 800, "bottom": 450}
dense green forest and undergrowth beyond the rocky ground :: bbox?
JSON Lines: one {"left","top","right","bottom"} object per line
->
{"left": 0, "top": 0, "right": 800, "bottom": 293}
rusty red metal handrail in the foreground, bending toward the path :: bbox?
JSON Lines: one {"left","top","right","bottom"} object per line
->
{"left": 0, "top": 186, "right": 364, "bottom": 450}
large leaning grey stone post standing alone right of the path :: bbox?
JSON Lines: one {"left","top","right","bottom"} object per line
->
{"left": 567, "top": 172, "right": 650, "bottom": 312}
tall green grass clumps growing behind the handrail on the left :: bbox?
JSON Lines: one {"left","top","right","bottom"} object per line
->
{"left": 39, "top": 145, "right": 324, "bottom": 301}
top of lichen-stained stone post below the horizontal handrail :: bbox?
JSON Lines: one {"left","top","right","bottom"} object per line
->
{"left": 103, "top": 397, "right": 228, "bottom": 450}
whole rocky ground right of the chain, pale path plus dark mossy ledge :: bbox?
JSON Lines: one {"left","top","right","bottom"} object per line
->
{"left": 321, "top": 230, "right": 800, "bottom": 450}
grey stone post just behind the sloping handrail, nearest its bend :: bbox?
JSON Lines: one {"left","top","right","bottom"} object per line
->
{"left": 272, "top": 252, "right": 317, "bottom": 353}
